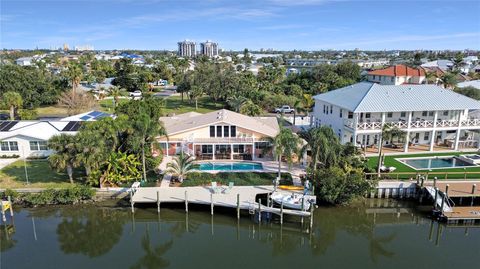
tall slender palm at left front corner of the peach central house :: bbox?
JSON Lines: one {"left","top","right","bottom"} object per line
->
{"left": 133, "top": 112, "right": 166, "bottom": 181}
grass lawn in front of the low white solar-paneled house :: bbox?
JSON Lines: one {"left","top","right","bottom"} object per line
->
{"left": 0, "top": 160, "right": 84, "bottom": 189}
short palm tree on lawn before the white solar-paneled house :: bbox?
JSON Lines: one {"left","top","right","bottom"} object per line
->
{"left": 48, "top": 134, "right": 79, "bottom": 183}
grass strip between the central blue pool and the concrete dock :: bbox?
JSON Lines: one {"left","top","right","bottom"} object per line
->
{"left": 182, "top": 172, "right": 293, "bottom": 187}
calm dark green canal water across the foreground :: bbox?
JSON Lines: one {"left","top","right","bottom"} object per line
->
{"left": 0, "top": 200, "right": 480, "bottom": 269}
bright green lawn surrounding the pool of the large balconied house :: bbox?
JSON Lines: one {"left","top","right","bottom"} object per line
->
{"left": 368, "top": 152, "right": 480, "bottom": 179}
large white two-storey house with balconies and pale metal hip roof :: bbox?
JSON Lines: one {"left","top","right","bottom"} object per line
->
{"left": 313, "top": 82, "right": 480, "bottom": 152}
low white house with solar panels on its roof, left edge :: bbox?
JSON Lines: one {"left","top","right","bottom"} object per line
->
{"left": 0, "top": 111, "right": 112, "bottom": 158}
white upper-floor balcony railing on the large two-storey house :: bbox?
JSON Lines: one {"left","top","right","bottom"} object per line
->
{"left": 344, "top": 119, "right": 480, "bottom": 130}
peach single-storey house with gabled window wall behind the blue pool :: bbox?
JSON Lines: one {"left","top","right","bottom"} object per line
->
{"left": 157, "top": 109, "right": 280, "bottom": 160}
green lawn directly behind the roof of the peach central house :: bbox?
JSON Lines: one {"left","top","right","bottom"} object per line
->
{"left": 161, "top": 96, "right": 225, "bottom": 114}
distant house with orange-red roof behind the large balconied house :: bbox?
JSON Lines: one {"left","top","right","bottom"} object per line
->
{"left": 367, "top": 64, "right": 425, "bottom": 85}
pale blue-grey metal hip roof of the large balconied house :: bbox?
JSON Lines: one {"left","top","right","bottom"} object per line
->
{"left": 315, "top": 82, "right": 480, "bottom": 112}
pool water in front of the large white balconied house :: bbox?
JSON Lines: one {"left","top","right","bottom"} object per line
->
{"left": 400, "top": 157, "right": 475, "bottom": 170}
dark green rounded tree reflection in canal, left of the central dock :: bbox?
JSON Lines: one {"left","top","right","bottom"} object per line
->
{"left": 57, "top": 208, "right": 128, "bottom": 257}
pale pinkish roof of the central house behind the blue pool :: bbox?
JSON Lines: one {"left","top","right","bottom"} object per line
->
{"left": 160, "top": 109, "right": 280, "bottom": 136}
